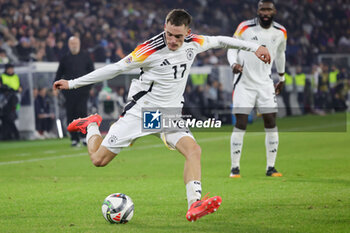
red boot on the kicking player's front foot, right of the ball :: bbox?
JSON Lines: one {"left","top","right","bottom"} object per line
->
{"left": 186, "top": 193, "right": 222, "bottom": 222}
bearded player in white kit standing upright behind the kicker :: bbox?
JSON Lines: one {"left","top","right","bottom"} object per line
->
{"left": 227, "top": 0, "right": 287, "bottom": 178}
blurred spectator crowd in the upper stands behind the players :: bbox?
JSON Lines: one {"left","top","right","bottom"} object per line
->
{"left": 0, "top": 0, "right": 350, "bottom": 66}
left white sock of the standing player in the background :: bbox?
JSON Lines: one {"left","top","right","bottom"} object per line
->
{"left": 231, "top": 127, "right": 245, "bottom": 168}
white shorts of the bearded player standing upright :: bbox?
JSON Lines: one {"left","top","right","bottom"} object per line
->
{"left": 232, "top": 82, "right": 278, "bottom": 115}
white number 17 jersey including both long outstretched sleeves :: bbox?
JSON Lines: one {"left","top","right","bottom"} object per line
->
{"left": 68, "top": 32, "right": 259, "bottom": 107}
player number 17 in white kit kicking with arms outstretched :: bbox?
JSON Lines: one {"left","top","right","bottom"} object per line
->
{"left": 54, "top": 9, "right": 270, "bottom": 221}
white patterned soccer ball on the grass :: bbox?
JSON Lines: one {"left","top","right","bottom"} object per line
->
{"left": 102, "top": 193, "right": 134, "bottom": 223}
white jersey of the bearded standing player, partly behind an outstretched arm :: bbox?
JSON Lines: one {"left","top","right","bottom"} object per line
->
{"left": 227, "top": 18, "right": 287, "bottom": 87}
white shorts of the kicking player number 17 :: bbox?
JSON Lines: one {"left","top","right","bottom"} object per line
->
{"left": 101, "top": 104, "right": 195, "bottom": 154}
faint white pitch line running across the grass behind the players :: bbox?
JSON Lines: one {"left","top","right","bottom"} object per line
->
{"left": 0, "top": 122, "right": 349, "bottom": 166}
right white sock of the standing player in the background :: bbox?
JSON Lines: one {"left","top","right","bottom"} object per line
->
{"left": 265, "top": 127, "right": 278, "bottom": 170}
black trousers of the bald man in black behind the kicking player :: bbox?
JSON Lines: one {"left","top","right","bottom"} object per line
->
{"left": 66, "top": 95, "right": 88, "bottom": 142}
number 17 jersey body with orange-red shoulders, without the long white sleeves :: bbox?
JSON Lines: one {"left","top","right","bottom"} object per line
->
{"left": 127, "top": 33, "right": 212, "bottom": 107}
